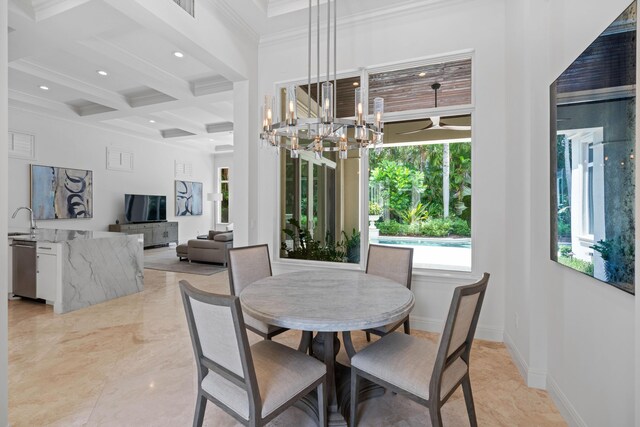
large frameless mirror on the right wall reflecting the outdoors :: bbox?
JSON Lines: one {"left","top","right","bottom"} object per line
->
{"left": 551, "top": 2, "right": 637, "bottom": 294}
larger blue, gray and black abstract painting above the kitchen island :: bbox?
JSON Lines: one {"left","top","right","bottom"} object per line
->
{"left": 31, "top": 165, "right": 93, "bottom": 219}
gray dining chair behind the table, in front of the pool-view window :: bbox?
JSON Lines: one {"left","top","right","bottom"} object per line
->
{"left": 365, "top": 245, "right": 413, "bottom": 342}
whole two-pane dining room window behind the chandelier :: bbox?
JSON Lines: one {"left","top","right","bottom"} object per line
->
{"left": 280, "top": 58, "right": 472, "bottom": 271}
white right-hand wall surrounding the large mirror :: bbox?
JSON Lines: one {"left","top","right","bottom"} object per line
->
{"left": 505, "top": 0, "right": 638, "bottom": 426}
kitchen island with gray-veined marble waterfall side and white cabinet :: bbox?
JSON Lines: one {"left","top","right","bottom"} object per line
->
{"left": 9, "top": 229, "right": 144, "bottom": 313}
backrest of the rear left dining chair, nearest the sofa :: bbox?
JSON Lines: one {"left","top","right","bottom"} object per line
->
{"left": 229, "top": 245, "right": 272, "bottom": 295}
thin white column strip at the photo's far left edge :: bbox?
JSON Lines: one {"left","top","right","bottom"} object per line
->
{"left": 0, "top": 0, "right": 9, "bottom": 426}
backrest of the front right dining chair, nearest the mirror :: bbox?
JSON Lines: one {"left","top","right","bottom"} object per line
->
{"left": 429, "top": 273, "right": 489, "bottom": 399}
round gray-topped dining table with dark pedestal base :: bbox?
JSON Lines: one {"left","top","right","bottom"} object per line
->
{"left": 240, "top": 270, "right": 415, "bottom": 426}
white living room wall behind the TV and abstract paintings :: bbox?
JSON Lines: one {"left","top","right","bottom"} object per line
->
{"left": 5, "top": 109, "right": 213, "bottom": 242}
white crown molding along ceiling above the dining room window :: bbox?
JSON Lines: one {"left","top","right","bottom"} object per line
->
{"left": 260, "top": 0, "right": 478, "bottom": 46}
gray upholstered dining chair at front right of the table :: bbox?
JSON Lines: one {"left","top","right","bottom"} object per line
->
{"left": 351, "top": 273, "right": 489, "bottom": 427}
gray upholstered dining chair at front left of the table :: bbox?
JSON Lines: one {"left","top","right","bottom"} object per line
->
{"left": 180, "top": 280, "right": 327, "bottom": 427}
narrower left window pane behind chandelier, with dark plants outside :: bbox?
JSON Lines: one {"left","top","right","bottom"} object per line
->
{"left": 280, "top": 77, "right": 361, "bottom": 263}
